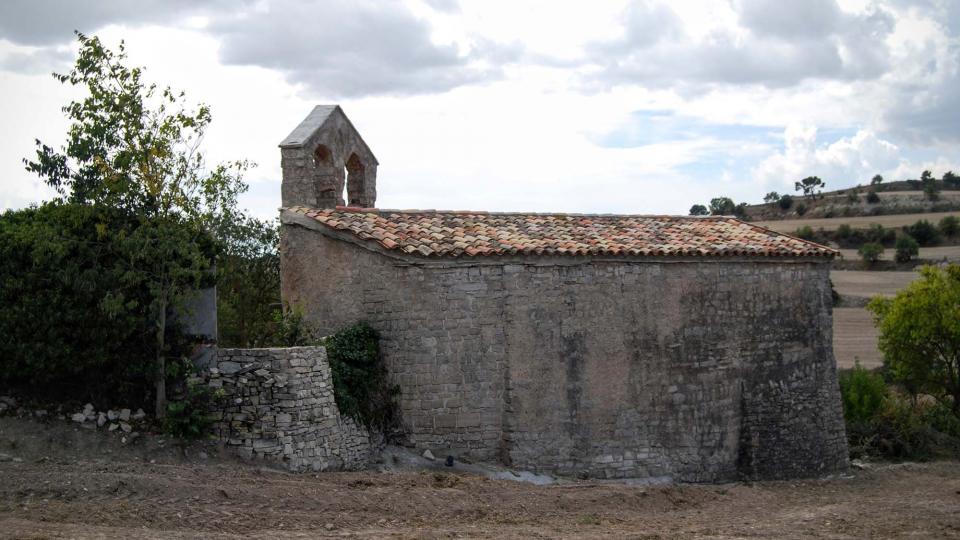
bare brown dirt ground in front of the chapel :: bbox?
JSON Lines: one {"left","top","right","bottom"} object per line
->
{"left": 0, "top": 418, "right": 960, "bottom": 539}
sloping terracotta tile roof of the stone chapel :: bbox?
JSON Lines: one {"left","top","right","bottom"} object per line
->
{"left": 288, "top": 206, "right": 838, "bottom": 258}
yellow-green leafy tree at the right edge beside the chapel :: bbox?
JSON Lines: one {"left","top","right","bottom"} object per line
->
{"left": 867, "top": 264, "right": 960, "bottom": 417}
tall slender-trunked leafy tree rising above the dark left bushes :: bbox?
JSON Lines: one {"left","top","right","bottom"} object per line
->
{"left": 24, "top": 33, "right": 248, "bottom": 418}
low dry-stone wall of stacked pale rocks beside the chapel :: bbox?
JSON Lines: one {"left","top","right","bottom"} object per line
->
{"left": 206, "top": 347, "right": 378, "bottom": 471}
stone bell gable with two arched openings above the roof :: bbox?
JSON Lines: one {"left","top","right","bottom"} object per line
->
{"left": 280, "top": 105, "right": 378, "bottom": 208}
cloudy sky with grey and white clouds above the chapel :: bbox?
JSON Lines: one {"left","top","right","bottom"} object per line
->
{"left": 0, "top": 0, "right": 960, "bottom": 217}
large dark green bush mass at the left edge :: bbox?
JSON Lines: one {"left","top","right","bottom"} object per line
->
{"left": 0, "top": 202, "right": 199, "bottom": 408}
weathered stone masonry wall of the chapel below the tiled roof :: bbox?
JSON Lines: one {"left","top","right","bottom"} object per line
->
{"left": 281, "top": 224, "right": 847, "bottom": 481}
